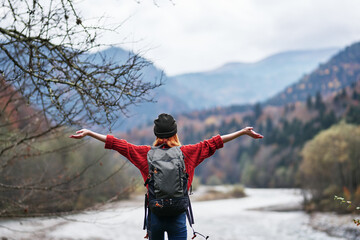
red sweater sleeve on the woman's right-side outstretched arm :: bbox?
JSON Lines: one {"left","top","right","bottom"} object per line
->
{"left": 181, "top": 135, "right": 224, "bottom": 168}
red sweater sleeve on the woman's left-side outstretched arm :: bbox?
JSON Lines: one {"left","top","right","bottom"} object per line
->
{"left": 105, "top": 135, "right": 151, "bottom": 176}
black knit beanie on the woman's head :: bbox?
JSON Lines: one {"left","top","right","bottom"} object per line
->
{"left": 154, "top": 113, "right": 177, "bottom": 138}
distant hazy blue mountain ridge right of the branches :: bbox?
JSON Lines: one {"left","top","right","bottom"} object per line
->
{"left": 164, "top": 48, "right": 339, "bottom": 110}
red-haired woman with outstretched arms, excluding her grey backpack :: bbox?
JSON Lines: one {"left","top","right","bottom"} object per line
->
{"left": 70, "top": 113, "right": 263, "bottom": 240}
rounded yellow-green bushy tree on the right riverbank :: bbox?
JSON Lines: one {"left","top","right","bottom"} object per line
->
{"left": 300, "top": 122, "right": 360, "bottom": 208}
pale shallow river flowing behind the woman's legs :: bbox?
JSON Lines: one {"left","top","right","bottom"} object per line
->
{"left": 0, "top": 189, "right": 356, "bottom": 240}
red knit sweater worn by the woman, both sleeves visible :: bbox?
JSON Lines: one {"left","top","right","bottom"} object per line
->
{"left": 105, "top": 135, "right": 224, "bottom": 189}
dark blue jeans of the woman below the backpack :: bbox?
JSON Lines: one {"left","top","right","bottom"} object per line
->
{"left": 149, "top": 212, "right": 187, "bottom": 240}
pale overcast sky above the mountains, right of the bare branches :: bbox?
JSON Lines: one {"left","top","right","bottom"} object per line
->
{"left": 79, "top": 0, "right": 360, "bottom": 75}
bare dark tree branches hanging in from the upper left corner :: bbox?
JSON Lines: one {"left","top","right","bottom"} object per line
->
{"left": 0, "top": 0, "right": 159, "bottom": 129}
